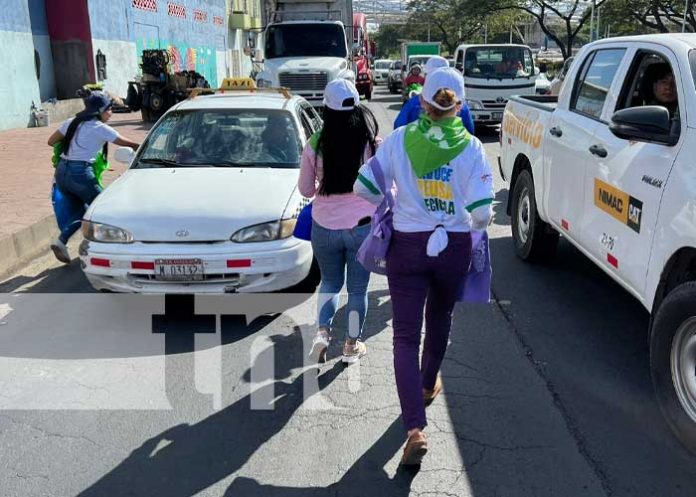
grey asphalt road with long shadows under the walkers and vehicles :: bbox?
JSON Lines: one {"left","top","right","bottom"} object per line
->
{"left": 0, "top": 88, "right": 696, "bottom": 497}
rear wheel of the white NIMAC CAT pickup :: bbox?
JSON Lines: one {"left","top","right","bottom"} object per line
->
{"left": 512, "top": 170, "right": 558, "bottom": 262}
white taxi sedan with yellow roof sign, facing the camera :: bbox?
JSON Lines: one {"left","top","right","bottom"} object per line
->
{"left": 80, "top": 90, "right": 321, "bottom": 293}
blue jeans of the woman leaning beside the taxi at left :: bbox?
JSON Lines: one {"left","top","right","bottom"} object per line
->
{"left": 56, "top": 159, "right": 102, "bottom": 243}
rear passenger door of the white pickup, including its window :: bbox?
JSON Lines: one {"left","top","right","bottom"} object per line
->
{"left": 544, "top": 50, "right": 625, "bottom": 236}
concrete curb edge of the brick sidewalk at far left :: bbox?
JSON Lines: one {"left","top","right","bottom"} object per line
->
{"left": 0, "top": 215, "right": 58, "bottom": 280}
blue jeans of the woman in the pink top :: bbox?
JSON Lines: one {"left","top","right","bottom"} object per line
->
{"left": 312, "top": 222, "right": 370, "bottom": 339}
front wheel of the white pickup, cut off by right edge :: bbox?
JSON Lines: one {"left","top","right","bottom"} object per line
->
{"left": 650, "top": 281, "right": 696, "bottom": 454}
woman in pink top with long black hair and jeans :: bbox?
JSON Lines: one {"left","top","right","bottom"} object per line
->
{"left": 298, "top": 79, "right": 378, "bottom": 363}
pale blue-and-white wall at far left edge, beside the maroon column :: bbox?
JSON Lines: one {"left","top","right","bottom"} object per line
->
{"left": 0, "top": 0, "right": 41, "bottom": 129}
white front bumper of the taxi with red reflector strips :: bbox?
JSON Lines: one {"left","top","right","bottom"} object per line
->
{"left": 80, "top": 237, "right": 313, "bottom": 293}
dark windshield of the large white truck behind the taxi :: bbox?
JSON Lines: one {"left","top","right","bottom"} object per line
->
{"left": 266, "top": 23, "right": 348, "bottom": 59}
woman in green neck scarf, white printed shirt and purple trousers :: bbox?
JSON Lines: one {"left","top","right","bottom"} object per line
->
{"left": 354, "top": 68, "right": 494, "bottom": 465}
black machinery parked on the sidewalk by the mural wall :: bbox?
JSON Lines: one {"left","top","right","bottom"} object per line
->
{"left": 126, "top": 49, "right": 210, "bottom": 122}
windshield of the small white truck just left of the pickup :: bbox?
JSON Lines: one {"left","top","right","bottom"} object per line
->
{"left": 464, "top": 47, "right": 534, "bottom": 79}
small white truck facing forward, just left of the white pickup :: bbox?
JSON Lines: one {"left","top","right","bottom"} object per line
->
{"left": 454, "top": 44, "right": 538, "bottom": 125}
